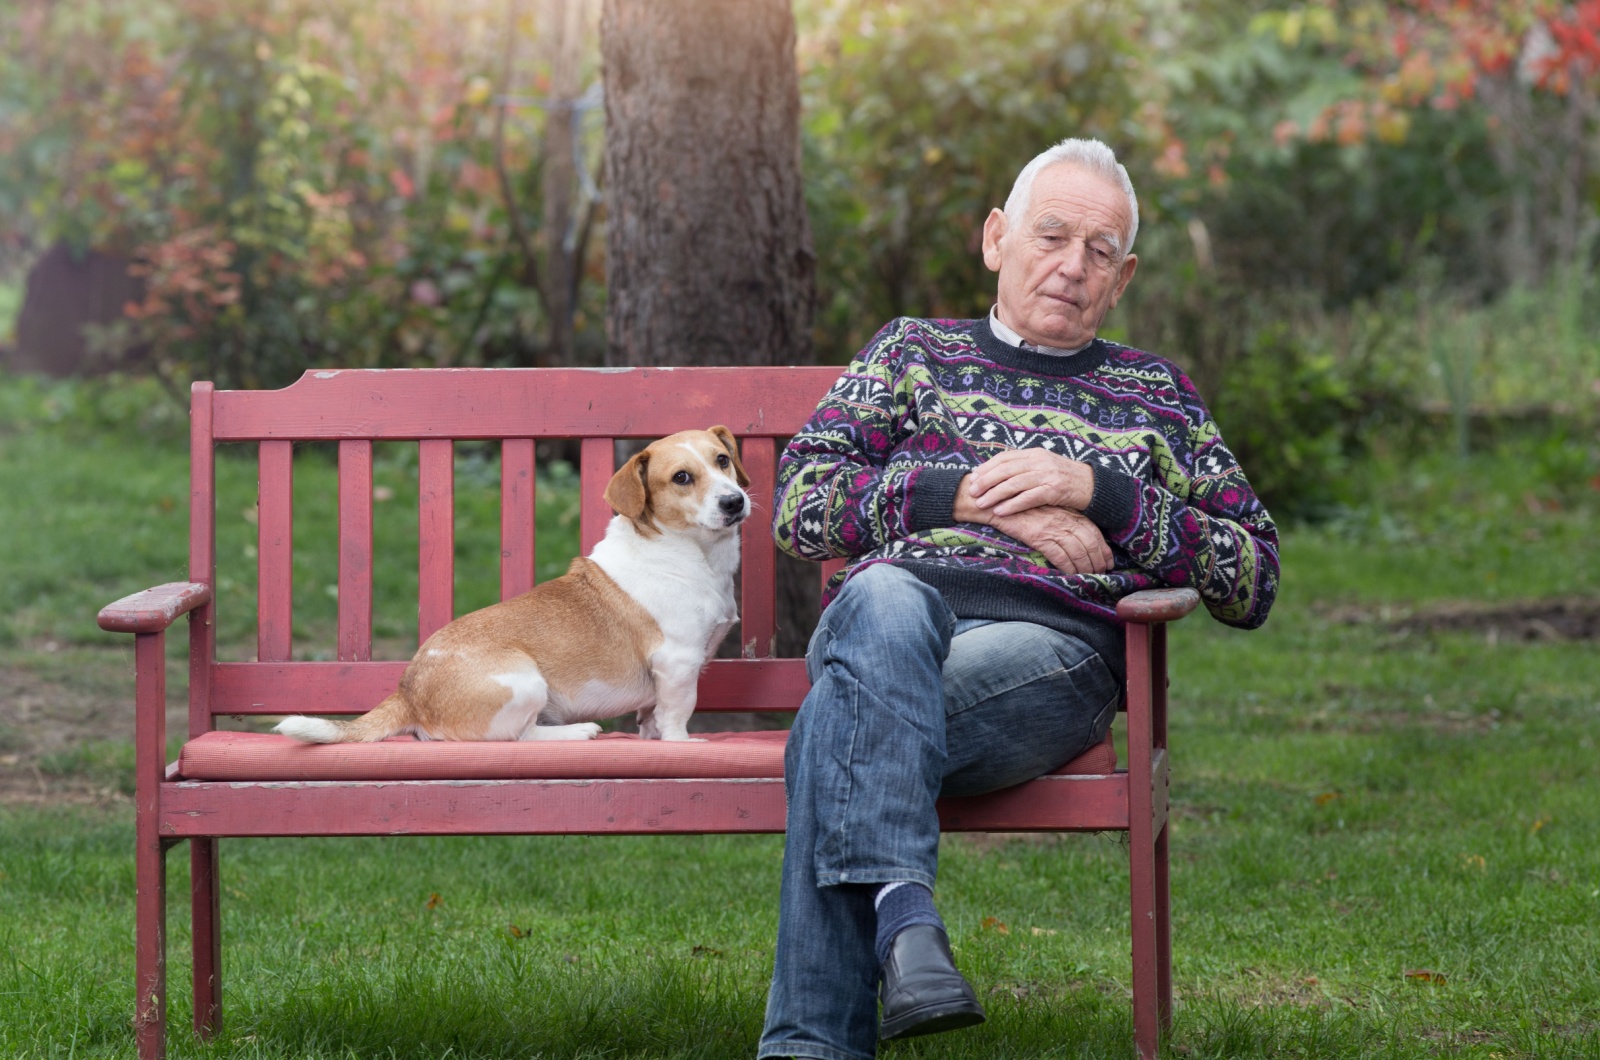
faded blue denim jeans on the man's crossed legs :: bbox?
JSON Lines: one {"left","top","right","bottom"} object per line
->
{"left": 757, "top": 564, "right": 1122, "bottom": 1060}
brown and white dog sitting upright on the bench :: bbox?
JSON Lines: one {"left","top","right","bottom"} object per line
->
{"left": 277, "top": 426, "right": 750, "bottom": 743}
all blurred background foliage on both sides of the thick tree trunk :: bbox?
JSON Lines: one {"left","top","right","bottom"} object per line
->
{"left": 0, "top": 0, "right": 1600, "bottom": 514}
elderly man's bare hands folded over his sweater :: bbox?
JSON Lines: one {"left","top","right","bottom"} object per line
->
{"left": 955, "top": 448, "right": 1112, "bottom": 575}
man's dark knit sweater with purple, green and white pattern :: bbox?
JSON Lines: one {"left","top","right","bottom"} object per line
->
{"left": 773, "top": 317, "right": 1278, "bottom": 677}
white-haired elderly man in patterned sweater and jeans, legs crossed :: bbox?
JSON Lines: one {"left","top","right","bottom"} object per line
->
{"left": 758, "top": 139, "right": 1278, "bottom": 1060}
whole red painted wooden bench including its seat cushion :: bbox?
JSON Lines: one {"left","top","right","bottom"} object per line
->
{"left": 99, "top": 368, "right": 1198, "bottom": 1060}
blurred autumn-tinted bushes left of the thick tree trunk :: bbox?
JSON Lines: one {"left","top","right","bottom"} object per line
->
{"left": 0, "top": 0, "right": 598, "bottom": 386}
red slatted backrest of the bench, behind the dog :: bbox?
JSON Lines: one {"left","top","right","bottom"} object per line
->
{"left": 189, "top": 367, "right": 840, "bottom": 735}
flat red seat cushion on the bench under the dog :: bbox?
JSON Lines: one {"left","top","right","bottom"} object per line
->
{"left": 178, "top": 729, "right": 1117, "bottom": 780}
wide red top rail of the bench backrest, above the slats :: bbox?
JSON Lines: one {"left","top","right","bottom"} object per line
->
{"left": 214, "top": 365, "right": 840, "bottom": 442}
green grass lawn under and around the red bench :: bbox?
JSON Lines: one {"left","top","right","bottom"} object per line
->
{"left": 0, "top": 369, "right": 1600, "bottom": 1060}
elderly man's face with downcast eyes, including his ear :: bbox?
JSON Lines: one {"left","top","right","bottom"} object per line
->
{"left": 984, "top": 162, "right": 1139, "bottom": 349}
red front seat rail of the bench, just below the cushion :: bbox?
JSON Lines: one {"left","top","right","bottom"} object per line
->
{"left": 150, "top": 773, "right": 1128, "bottom": 837}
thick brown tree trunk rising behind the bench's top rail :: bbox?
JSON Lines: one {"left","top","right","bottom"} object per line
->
{"left": 600, "top": 0, "right": 814, "bottom": 365}
